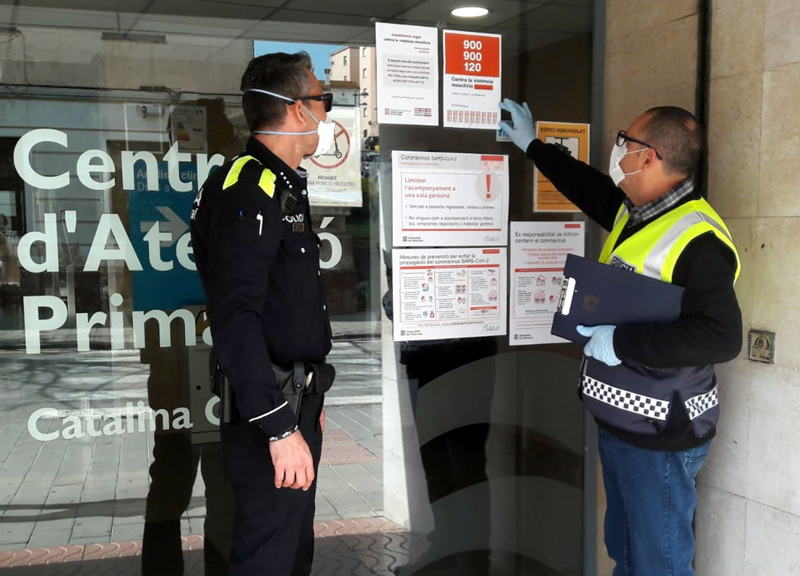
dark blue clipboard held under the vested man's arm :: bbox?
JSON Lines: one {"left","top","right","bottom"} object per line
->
{"left": 550, "top": 254, "right": 683, "bottom": 344}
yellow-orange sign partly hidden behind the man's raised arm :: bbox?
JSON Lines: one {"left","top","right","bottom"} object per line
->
{"left": 533, "top": 122, "right": 589, "bottom": 212}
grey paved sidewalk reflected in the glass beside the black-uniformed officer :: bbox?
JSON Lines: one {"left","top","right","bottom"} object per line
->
{"left": 0, "top": 404, "right": 383, "bottom": 552}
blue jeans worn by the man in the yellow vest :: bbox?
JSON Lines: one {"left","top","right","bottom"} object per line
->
{"left": 598, "top": 428, "right": 711, "bottom": 576}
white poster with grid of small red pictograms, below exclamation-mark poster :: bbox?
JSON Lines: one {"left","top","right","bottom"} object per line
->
{"left": 392, "top": 248, "right": 507, "bottom": 341}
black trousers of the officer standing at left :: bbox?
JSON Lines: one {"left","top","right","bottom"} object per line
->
{"left": 221, "top": 394, "right": 323, "bottom": 576}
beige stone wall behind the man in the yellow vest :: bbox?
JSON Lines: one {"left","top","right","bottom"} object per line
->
{"left": 598, "top": 0, "right": 800, "bottom": 576}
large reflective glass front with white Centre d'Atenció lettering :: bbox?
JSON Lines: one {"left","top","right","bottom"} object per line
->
{"left": 0, "top": 0, "right": 592, "bottom": 575}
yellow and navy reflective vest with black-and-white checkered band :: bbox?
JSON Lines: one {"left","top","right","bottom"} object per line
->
{"left": 581, "top": 199, "right": 741, "bottom": 438}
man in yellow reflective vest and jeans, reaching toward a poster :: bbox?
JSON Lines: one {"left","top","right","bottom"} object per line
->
{"left": 500, "top": 99, "right": 742, "bottom": 576}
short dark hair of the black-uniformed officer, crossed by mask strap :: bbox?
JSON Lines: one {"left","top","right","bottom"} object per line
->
{"left": 241, "top": 51, "right": 313, "bottom": 131}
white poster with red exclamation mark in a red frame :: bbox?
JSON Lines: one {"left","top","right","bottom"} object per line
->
{"left": 392, "top": 151, "right": 508, "bottom": 246}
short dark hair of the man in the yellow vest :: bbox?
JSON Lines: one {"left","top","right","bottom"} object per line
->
{"left": 643, "top": 106, "right": 703, "bottom": 176}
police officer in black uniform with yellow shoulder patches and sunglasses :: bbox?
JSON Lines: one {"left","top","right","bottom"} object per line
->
{"left": 191, "top": 52, "right": 334, "bottom": 576}
